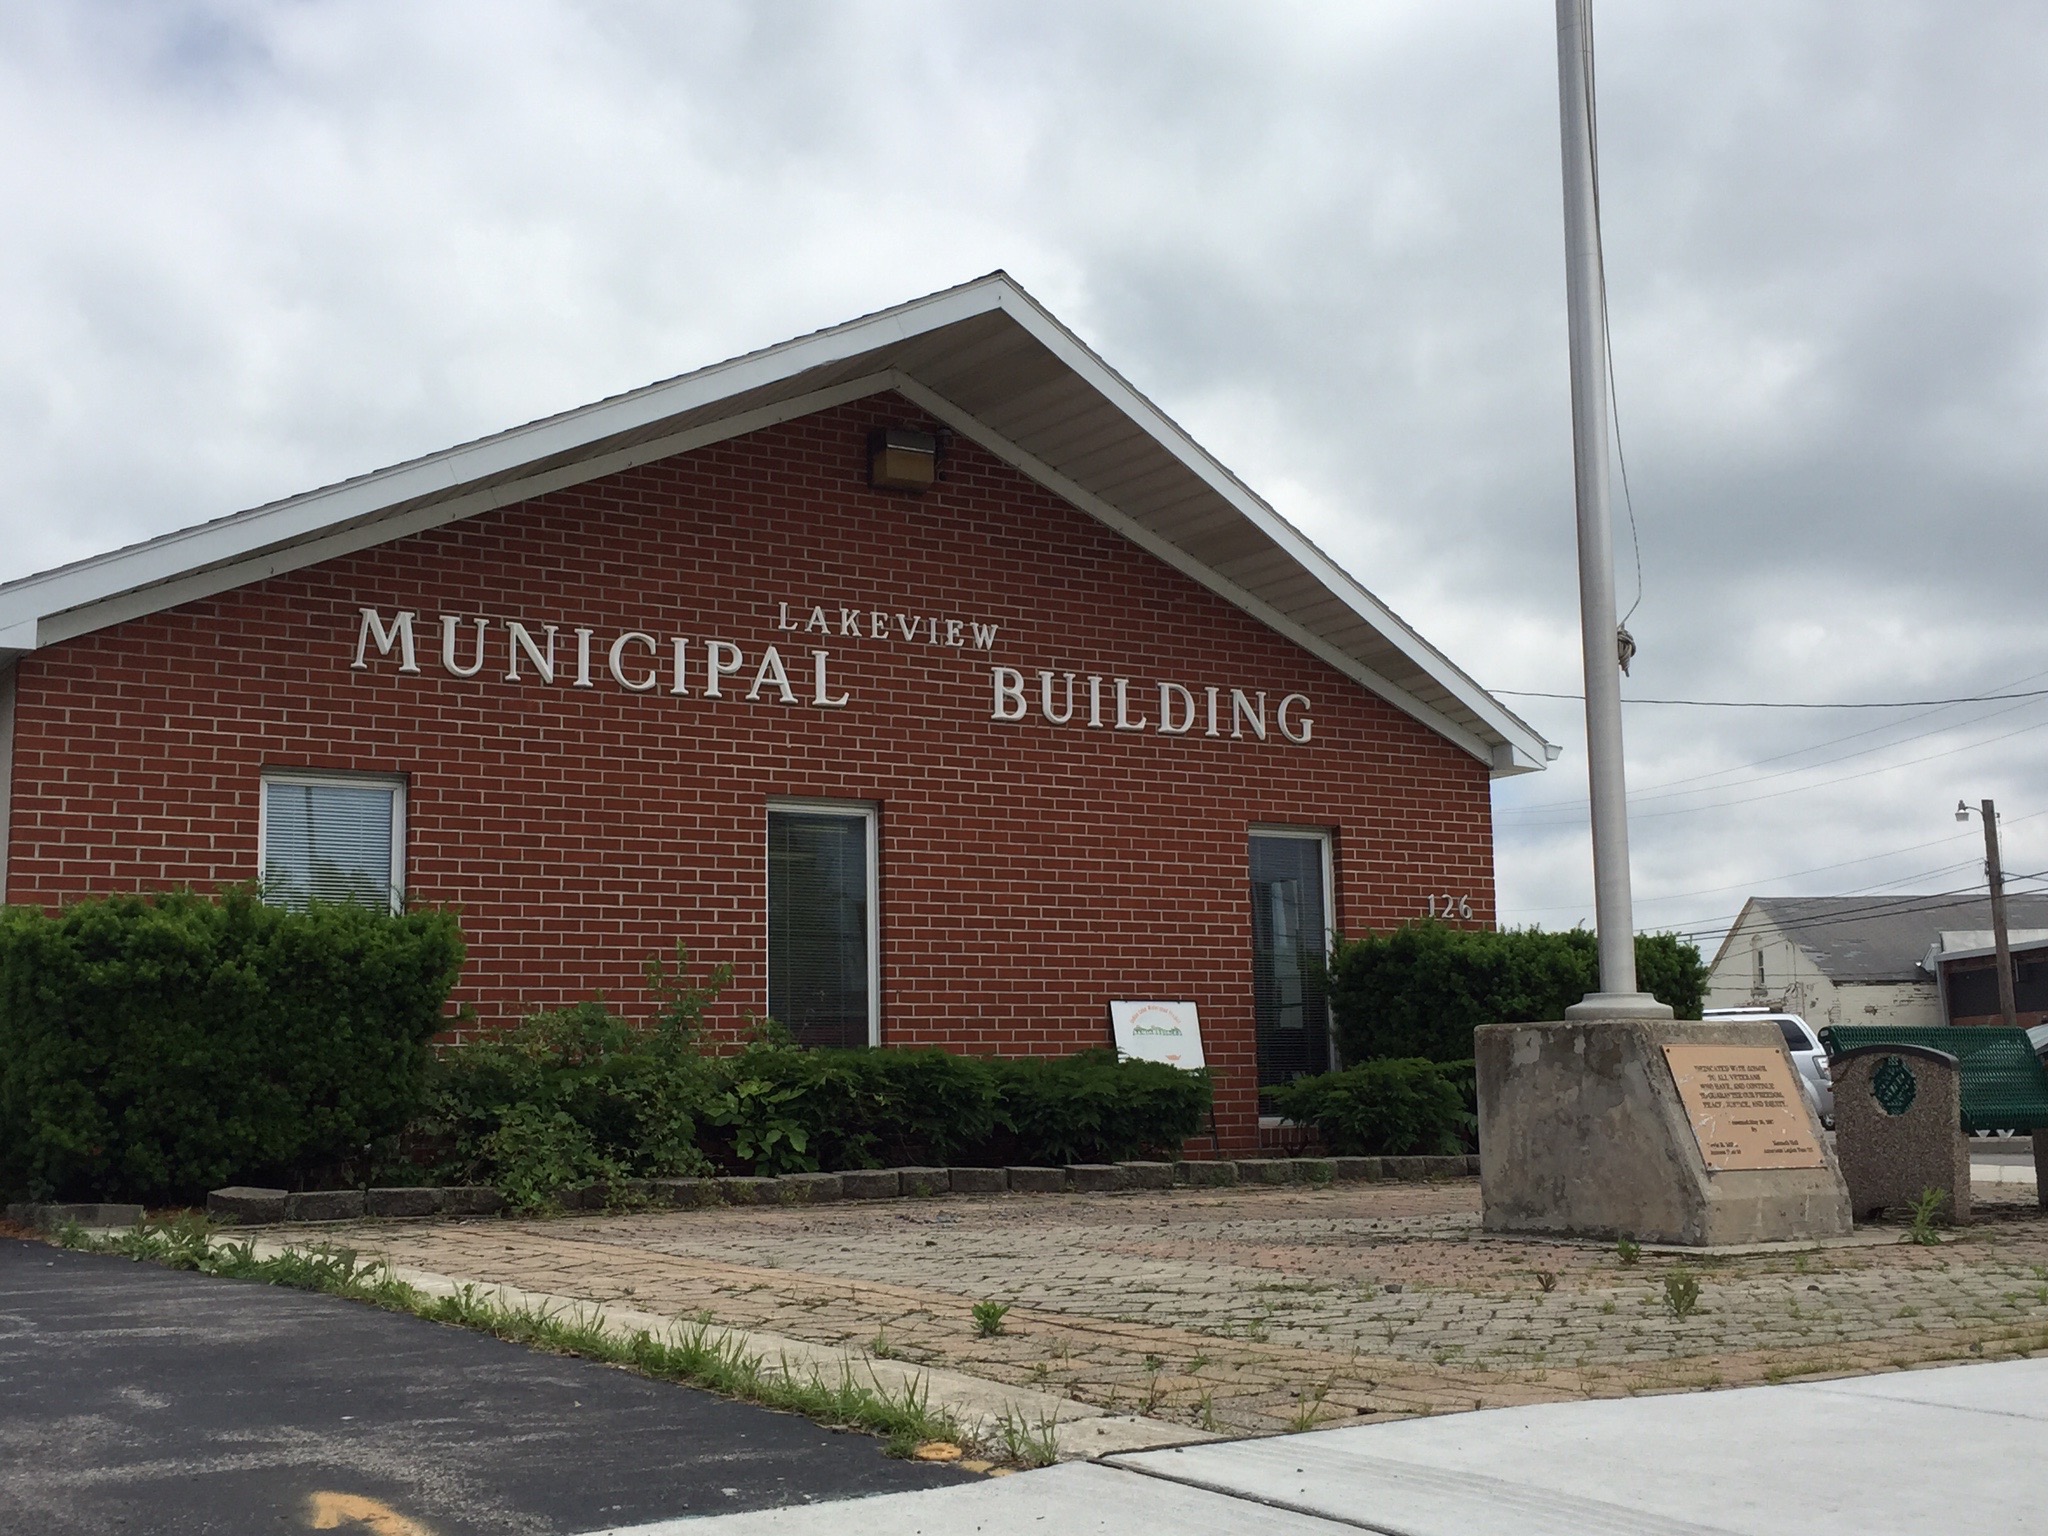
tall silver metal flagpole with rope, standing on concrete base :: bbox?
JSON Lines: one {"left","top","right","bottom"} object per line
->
{"left": 1556, "top": 0, "right": 1671, "bottom": 1018}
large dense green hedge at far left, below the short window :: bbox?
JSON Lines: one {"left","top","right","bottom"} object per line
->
{"left": 0, "top": 891, "right": 463, "bottom": 1202}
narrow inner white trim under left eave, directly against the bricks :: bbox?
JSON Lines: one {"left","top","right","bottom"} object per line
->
{"left": 32, "top": 373, "right": 899, "bottom": 649}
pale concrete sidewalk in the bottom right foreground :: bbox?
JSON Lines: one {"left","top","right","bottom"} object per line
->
{"left": 598, "top": 1360, "right": 2048, "bottom": 1536}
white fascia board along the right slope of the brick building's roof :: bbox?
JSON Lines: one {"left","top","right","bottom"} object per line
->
{"left": 983, "top": 285, "right": 1548, "bottom": 772}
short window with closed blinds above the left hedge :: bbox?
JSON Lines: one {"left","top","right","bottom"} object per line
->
{"left": 256, "top": 772, "right": 406, "bottom": 911}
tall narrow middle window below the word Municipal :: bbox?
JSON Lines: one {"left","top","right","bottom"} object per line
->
{"left": 768, "top": 801, "right": 881, "bottom": 1047}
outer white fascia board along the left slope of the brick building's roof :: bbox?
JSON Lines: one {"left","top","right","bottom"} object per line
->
{"left": 0, "top": 279, "right": 1008, "bottom": 645}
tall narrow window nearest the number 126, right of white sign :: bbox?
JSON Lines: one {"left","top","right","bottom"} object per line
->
{"left": 1251, "top": 829, "right": 1331, "bottom": 1087}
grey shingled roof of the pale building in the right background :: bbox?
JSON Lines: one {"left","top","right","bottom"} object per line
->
{"left": 1714, "top": 895, "right": 2048, "bottom": 983}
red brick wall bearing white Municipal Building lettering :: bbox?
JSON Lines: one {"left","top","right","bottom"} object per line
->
{"left": 6, "top": 397, "right": 1493, "bottom": 1145}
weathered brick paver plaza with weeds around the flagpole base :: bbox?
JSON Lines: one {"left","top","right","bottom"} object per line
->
{"left": 330, "top": 1182, "right": 2048, "bottom": 1430}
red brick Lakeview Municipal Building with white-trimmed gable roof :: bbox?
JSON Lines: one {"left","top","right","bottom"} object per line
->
{"left": 0, "top": 274, "right": 1548, "bottom": 1145}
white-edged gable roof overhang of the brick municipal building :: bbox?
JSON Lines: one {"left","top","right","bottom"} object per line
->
{"left": 0, "top": 272, "right": 1556, "bottom": 776}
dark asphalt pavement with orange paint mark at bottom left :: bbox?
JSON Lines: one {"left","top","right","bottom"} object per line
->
{"left": 0, "top": 1239, "right": 967, "bottom": 1536}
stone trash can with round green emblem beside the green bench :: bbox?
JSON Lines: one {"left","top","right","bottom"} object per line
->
{"left": 1831, "top": 1044, "right": 1970, "bottom": 1221}
